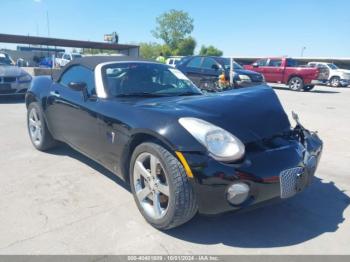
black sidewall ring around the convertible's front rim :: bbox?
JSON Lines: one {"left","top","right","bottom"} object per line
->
{"left": 129, "top": 143, "right": 180, "bottom": 228}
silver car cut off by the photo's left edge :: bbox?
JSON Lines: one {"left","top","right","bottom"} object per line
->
{"left": 0, "top": 52, "right": 32, "bottom": 96}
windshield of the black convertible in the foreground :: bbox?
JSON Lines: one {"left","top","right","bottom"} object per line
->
{"left": 102, "top": 62, "right": 202, "bottom": 97}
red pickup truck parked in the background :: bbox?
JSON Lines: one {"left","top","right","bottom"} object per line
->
{"left": 244, "top": 57, "right": 319, "bottom": 91}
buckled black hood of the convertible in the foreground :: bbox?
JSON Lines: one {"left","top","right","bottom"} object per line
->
{"left": 127, "top": 85, "right": 290, "bottom": 143}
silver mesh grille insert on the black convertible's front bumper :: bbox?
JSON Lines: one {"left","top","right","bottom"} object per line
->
{"left": 280, "top": 167, "right": 304, "bottom": 198}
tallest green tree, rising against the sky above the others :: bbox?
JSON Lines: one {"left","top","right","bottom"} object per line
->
{"left": 152, "top": 9, "right": 194, "bottom": 50}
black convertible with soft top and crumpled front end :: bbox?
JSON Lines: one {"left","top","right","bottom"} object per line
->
{"left": 26, "top": 57, "right": 322, "bottom": 229}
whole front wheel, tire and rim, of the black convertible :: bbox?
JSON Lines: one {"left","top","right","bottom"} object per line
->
{"left": 129, "top": 142, "right": 198, "bottom": 230}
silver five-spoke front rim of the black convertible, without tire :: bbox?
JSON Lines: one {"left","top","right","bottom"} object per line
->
{"left": 133, "top": 152, "right": 170, "bottom": 219}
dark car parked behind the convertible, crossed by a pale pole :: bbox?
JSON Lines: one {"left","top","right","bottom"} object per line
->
{"left": 176, "top": 56, "right": 264, "bottom": 90}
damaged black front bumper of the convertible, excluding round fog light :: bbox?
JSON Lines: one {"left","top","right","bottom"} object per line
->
{"left": 184, "top": 121, "right": 322, "bottom": 214}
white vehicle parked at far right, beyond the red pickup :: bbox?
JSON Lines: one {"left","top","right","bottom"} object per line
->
{"left": 308, "top": 62, "right": 350, "bottom": 87}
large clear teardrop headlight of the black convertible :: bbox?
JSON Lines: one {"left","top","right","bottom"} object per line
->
{"left": 179, "top": 117, "right": 245, "bottom": 162}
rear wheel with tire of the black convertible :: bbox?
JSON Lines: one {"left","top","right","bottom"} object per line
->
{"left": 27, "top": 102, "right": 57, "bottom": 151}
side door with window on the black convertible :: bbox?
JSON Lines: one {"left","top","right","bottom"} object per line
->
{"left": 46, "top": 66, "right": 101, "bottom": 160}
